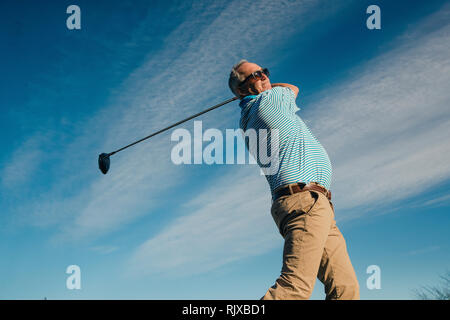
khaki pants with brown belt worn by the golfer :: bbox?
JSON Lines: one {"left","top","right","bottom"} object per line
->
{"left": 261, "top": 191, "right": 359, "bottom": 300}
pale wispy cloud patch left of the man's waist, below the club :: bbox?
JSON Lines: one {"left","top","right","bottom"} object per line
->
{"left": 128, "top": 166, "right": 282, "bottom": 276}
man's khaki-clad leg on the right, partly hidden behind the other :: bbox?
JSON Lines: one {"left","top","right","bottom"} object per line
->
{"left": 317, "top": 204, "right": 359, "bottom": 300}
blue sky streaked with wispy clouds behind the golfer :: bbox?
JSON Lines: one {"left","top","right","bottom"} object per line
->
{"left": 0, "top": 0, "right": 450, "bottom": 299}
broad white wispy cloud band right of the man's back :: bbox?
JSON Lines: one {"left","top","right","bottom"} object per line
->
{"left": 302, "top": 6, "right": 450, "bottom": 217}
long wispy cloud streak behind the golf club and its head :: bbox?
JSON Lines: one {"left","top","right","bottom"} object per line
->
{"left": 2, "top": 1, "right": 322, "bottom": 241}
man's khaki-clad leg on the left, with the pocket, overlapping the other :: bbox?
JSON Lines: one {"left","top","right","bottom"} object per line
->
{"left": 262, "top": 192, "right": 333, "bottom": 300}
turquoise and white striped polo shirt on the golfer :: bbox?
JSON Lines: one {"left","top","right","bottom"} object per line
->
{"left": 239, "top": 86, "right": 332, "bottom": 197}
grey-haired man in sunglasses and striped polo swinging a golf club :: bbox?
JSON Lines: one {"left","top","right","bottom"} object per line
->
{"left": 228, "top": 60, "right": 359, "bottom": 299}
